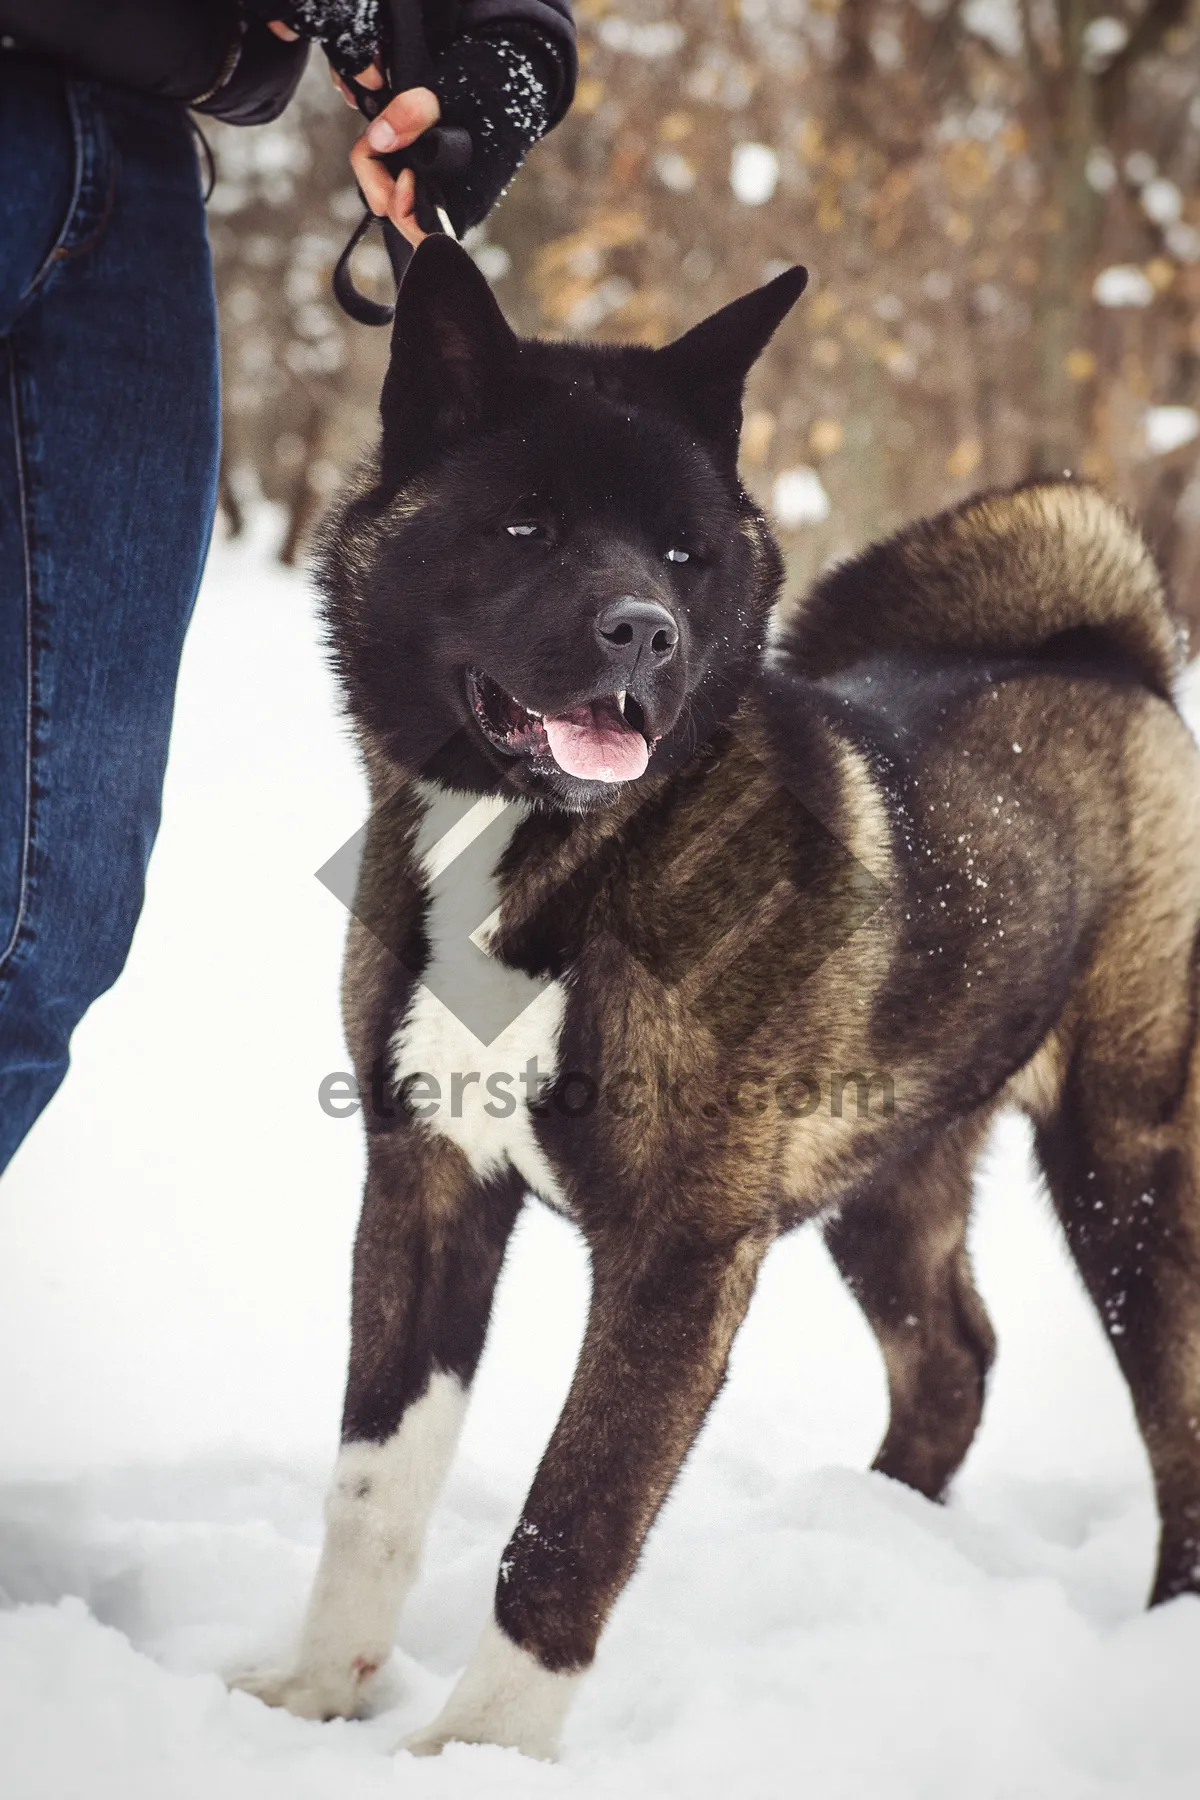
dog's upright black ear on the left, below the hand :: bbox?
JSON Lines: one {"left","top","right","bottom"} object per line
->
{"left": 380, "top": 236, "right": 516, "bottom": 488}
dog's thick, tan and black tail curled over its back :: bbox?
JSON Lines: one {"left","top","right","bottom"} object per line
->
{"left": 779, "top": 481, "right": 1184, "bottom": 700}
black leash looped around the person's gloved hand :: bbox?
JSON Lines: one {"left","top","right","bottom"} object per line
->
{"left": 333, "top": 0, "right": 471, "bottom": 326}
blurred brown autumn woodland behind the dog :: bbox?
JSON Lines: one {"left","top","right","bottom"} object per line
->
{"left": 204, "top": 0, "right": 1200, "bottom": 625}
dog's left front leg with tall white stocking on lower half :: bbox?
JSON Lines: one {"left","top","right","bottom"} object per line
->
{"left": 236, "top": 1125, "right": 522, "bottom": 1719}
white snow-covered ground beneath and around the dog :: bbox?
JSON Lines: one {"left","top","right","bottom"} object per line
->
{"left": 0, "top": 525, "right": 1200, "bottom": 1800}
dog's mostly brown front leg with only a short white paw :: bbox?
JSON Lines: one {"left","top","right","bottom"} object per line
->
{"left": 403, "top": 1237, "right": 766, "bottom": 1757}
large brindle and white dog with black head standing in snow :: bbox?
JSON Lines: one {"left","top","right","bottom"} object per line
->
{"left": 233, "top": 239, "right": 1200, "bottom": 1757}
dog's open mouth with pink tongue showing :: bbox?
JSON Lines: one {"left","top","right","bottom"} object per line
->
{"left": 466, "top": 670, "right": 653, "bottom": 781}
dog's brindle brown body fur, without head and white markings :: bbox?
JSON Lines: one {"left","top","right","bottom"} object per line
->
{"left": 239, "top": 246, "right": 1200, "bottom": 1748}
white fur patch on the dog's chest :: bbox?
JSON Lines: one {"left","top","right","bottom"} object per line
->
{"left": 392, "top": 790, "right": 565, "bottom": 1204}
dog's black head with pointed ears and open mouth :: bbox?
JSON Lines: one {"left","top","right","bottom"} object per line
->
{"left": 320, "top": 238, "right": 806, "bottom": 812}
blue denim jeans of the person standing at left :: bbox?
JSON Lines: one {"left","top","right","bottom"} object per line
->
{"left": 0, "top": 54, "right": 219, "bottom": 1170}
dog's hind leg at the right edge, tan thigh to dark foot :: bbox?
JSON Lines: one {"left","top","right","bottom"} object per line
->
{"left": 1029, "top": 702, "right": 1200, "bottom": 1600}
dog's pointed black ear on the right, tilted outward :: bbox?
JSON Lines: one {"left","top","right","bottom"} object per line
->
{"left": 655, "top": 266, "right": 808, "bottom": 463}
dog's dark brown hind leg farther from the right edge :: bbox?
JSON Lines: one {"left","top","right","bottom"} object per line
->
{"left": 826, "top": 1118, "right": 995, "bottom": 1499}
